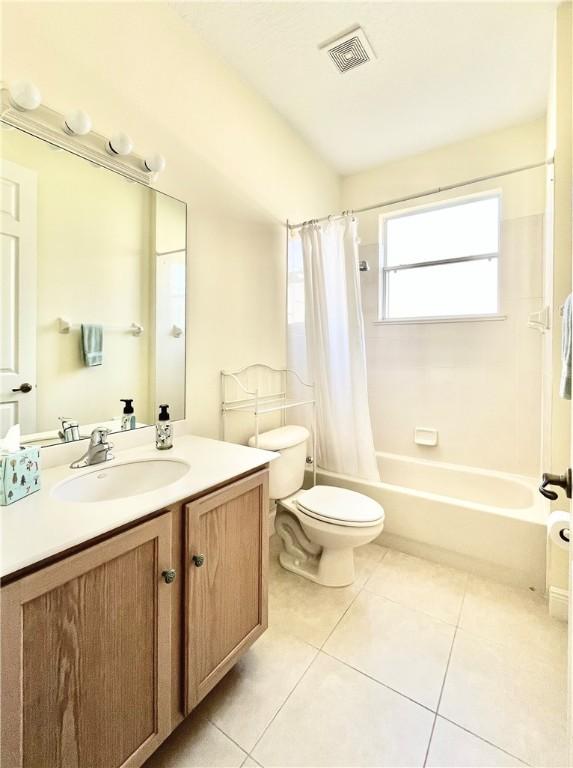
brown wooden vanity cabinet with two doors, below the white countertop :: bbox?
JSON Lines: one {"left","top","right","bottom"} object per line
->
{"left": 0, "top": 470, "right": 268, "bottom": 768}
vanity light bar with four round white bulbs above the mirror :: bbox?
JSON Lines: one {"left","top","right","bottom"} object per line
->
{"left": 0, "top": 81, "right": 165, "bottom": 186}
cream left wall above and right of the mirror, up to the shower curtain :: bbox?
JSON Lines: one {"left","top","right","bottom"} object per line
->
{"left": 1, "top": 2, "right": 340, "bottom": 436}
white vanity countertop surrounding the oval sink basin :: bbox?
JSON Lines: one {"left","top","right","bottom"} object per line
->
{"left": 0, "top": 435, "right": 277, "bottom": 577}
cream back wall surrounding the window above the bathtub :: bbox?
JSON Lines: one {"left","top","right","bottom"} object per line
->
{"left": 343, "top": 119, "right": 545, "bottom": 475}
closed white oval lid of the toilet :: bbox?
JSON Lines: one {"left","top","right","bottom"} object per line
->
{"left": 296, "top": 485, "right": 384, "bottom": 525}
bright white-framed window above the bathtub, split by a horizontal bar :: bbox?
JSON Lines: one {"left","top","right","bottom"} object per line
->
{"left": 381, "top": 194, "right": 501, "bottom": 320}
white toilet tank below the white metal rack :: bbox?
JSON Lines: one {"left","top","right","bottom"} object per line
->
{"left": 249, "top": 424, "right": 309, "bottom": 499}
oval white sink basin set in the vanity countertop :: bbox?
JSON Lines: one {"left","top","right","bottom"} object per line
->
{"left": 52, "top": 459, "right": 190, "bottom": 503}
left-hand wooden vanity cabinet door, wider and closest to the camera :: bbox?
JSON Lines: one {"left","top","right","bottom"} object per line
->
{"left": 1, "top": 514, "right": 171, "bottom": 768}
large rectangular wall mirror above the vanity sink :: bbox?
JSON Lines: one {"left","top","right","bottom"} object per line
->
{"left": 0, "top": 129, "right": 187, "bottom": 446}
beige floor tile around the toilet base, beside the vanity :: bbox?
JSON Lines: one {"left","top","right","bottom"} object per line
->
{"left": 269, "top": 536, "right": 386, "bottom": 648}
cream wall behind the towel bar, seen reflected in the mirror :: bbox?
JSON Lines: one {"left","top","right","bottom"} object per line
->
{"left": 2, "top": 131, "right": 153, "bottom": 432}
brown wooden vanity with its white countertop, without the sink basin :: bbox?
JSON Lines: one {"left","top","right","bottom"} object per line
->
{"left": 1, "top": 436, "right": 273, "bottom": 768}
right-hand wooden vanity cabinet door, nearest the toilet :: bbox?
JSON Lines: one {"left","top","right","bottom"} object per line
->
{"left": 185, "top": 470, "right": 268, "bottom": 713}
